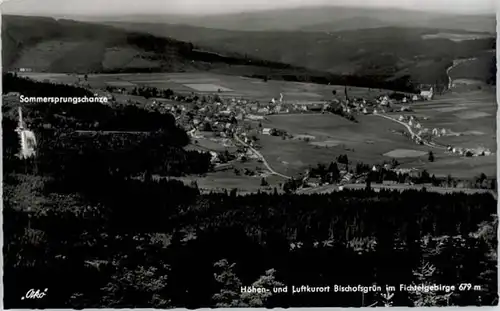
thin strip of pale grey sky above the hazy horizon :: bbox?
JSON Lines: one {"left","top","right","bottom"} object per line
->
{"left": 0, "top": 0, "right": 496, "bottom": 15}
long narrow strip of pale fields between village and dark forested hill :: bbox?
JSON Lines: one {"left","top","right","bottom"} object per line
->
{"left": 18, "top": 72, "right": 390, "bottom": 103}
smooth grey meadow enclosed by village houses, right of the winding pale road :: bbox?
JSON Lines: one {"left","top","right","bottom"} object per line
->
{"left": 259, "top": 114, "right": 429, "bottom": 175}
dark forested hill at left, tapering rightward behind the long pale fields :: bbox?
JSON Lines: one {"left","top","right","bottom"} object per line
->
{"left": 2, "top": 15, "right": 426, "bottom": 92}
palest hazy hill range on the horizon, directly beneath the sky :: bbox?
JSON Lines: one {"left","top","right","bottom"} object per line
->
{"left": 81, "top": 6, "right": 496, "bottom": 33}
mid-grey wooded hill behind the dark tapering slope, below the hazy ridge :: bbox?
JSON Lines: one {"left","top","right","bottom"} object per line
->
{"left": 101, "top": 22, "right": 496, "bottom": 84}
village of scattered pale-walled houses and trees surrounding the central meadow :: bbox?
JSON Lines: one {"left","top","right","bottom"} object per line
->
{"left": 4, "top": 77, "right": 492, "bottom": 192}
